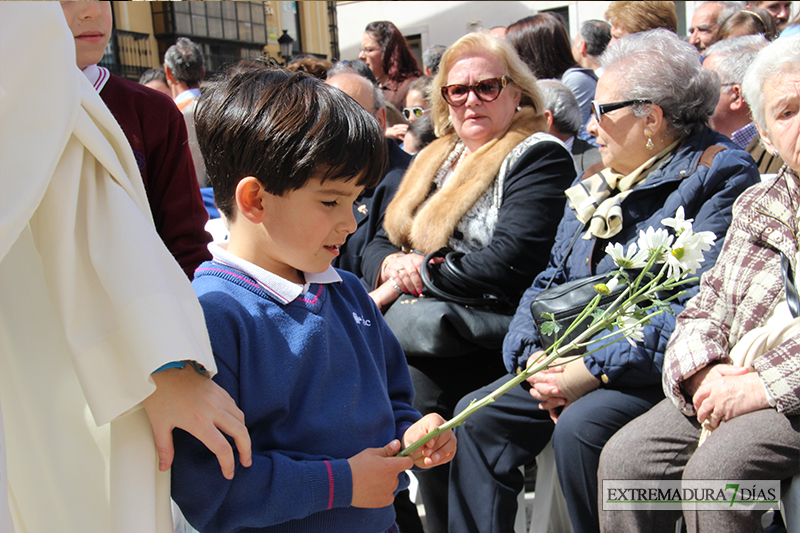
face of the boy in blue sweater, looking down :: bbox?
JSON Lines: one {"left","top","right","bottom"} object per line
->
{"left": 257, "top": 178, "right": 364, "bottom": 282}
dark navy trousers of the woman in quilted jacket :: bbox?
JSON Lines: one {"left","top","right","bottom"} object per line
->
{"left": 449, "top": 377, "right": 664, "bottom": 533}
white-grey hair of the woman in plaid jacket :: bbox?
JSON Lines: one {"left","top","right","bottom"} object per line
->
{"left": 742, "top": 35, "right": 800, "bottom": 129}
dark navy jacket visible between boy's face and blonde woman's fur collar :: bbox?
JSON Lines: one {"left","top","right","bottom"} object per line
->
{"left": 332, "top": 139, "right": 411, "bottom": 282}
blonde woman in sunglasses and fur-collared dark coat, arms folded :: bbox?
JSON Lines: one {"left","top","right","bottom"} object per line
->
{"left": 362, "top": 32, "right": 575, "bottom": 532}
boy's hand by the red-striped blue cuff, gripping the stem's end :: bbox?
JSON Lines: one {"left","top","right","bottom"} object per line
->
{"left": 347, "top": 440, "right": 414, "bottom": 509}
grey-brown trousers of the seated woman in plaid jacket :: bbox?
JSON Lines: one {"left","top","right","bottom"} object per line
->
{"left": 600, "top": 400, "right": 800, "bottom": 533}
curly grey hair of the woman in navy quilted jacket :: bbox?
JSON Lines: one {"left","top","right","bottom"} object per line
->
{"left": 600, "top": 28, "right": 720, "bottom": 138}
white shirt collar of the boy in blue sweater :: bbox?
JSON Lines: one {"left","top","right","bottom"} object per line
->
{"left": 208, "top": 243, "right": 342, "bottom": 303}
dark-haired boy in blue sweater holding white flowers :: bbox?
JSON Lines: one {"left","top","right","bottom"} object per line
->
{"left": 172, "top": 69, "right": 456, "bottom": 533}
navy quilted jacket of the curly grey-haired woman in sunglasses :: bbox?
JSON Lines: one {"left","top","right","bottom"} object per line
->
{"left": 503, "top": 128, "right": 760, "bottom": 387}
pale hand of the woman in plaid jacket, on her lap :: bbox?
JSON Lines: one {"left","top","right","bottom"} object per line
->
{"left": 692, "top": 365, "right": 769, "bottom": 429}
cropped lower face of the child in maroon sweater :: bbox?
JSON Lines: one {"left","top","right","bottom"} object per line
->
{"left": 61, "top": 2, "right": 111, "bottom": 70}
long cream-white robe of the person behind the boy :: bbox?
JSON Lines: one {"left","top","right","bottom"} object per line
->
{"left": 0, "top": 2, "right": 216, "bottom": 533}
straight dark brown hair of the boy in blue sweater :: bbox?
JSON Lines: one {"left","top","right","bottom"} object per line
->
{"left": 195, "top": 68, "right": 388, "bottom": 220}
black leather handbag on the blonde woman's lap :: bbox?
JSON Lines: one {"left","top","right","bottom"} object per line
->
{"left": 384, "top": 248, "right": 513, "bottom": 357}
